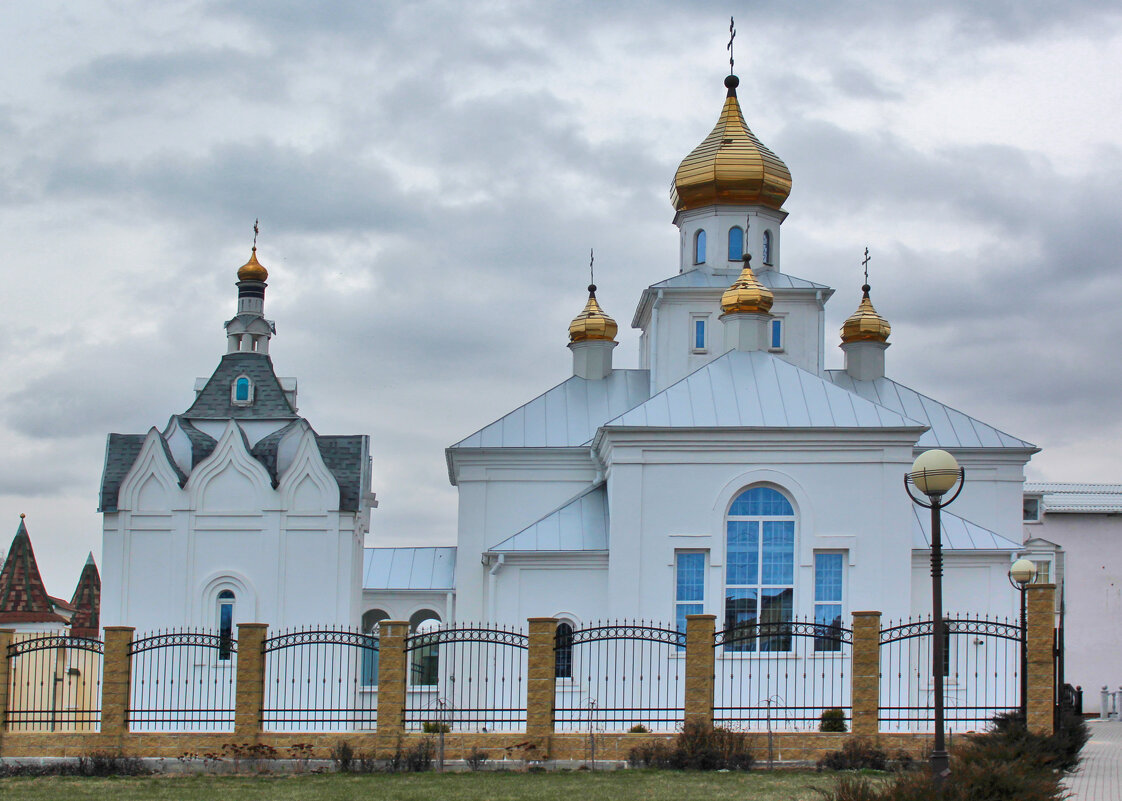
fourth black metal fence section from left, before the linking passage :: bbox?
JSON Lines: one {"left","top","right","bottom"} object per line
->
{"left": 404, "top": 625, "right": 530, "bottom": 731}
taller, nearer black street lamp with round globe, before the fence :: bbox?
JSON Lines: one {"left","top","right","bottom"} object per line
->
{"left": 904, "top": 450, "right": 966, "bottom": 785}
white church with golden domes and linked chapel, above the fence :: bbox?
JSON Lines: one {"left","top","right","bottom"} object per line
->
{"left": 101, "top": 75, "right": 1037, "bottom": 629}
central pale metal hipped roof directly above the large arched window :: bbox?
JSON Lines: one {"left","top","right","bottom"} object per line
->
{"left": 605, "top": 350, "right": 922, "bottom": 429}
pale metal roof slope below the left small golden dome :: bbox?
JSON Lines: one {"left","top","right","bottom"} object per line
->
{"left": 452, "top": 370, "right": 651, "bottom": 448}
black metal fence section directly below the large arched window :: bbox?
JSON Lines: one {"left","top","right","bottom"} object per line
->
{"left": 714, "top": 619, "right": 853, "bottom": 731}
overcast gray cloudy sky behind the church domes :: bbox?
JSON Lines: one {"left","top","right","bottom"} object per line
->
{"left": 0, "top": 0, "right": 1122, "bottom": 598}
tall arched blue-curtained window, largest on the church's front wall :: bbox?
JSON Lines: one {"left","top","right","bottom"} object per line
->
{"left": 725, "top": 487, "right": 794, "bottom": 651}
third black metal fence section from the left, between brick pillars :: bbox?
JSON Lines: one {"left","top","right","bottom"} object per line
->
{"left": 261, "top": 628, "right": 378, "bottom": 731}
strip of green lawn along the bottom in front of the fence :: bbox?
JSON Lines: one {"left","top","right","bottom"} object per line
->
{"left": 0, "top": 771, "right": 831, "bottom": 801}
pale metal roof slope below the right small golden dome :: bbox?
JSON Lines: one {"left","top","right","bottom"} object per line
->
{"left": 826, "top": 370, "right": 1036, "bottom": 450}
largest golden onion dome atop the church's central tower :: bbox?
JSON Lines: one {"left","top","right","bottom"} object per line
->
{"left": 670, "top": 75, "right": 791, "bottom": 211}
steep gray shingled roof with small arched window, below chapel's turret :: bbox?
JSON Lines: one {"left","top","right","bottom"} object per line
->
{"left": 183, "top": 351, "right": 297, "bottom": 420}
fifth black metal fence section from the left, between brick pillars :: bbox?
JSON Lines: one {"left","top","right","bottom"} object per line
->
{"left": 554, "top": 622, "right": 686, "bottom": 731}
